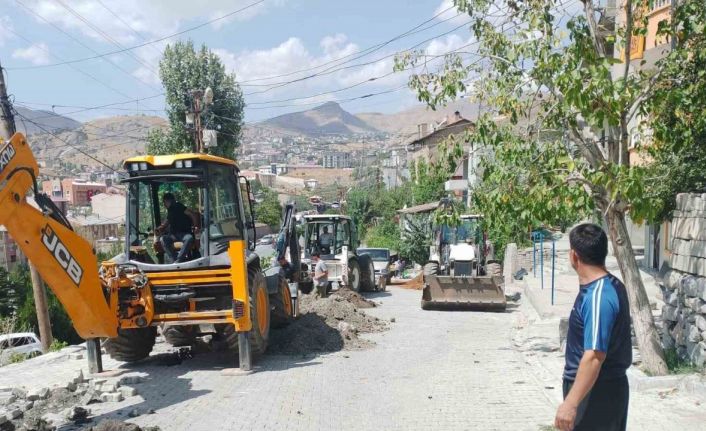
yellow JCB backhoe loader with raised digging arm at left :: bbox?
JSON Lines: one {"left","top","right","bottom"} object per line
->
{"left": 0, "top": 133, "right": 293, "bottom": 372}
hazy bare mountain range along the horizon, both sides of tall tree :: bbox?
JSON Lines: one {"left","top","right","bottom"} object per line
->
{"left": 16, "top": 101, "right": 478, "bottom": 165}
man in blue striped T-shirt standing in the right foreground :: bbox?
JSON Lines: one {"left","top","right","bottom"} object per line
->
{"left": 554, "top": 224, "right": 632, "bottom": 431}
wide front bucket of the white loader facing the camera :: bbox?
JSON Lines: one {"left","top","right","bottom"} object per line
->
{"left": 422, "top": 275, "right": 507, "bottom": 311}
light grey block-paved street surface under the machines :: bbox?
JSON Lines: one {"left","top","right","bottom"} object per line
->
{"left": 0, "top": 287, "right": 704, "bottom": 431}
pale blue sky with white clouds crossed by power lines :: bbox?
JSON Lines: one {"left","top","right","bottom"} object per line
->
{"left": 0, "top": 0, "right": 472, "bottom": 122}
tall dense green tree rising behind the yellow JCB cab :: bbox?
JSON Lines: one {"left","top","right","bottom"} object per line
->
{"left": 147, "top": 41, "right": 244, "bottom": 159}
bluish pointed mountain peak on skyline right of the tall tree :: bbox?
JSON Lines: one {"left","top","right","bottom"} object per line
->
{"left": 258, "top": 102, "right": 378, "bottom": 136}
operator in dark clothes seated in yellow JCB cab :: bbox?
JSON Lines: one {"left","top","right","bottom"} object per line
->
{"left": 156, "top": 193, "right": 198, "bottom": 263}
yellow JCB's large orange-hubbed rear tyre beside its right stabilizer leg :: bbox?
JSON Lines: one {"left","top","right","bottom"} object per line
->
{"left": 223, "top": 267, "right": 270, "bottom": 357}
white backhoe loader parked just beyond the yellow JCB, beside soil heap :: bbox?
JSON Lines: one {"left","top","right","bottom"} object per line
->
{"left": 299, "top": 214, "right": 375, "bottom": 293}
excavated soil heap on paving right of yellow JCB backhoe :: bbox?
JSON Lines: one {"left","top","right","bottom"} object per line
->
{"left": 268, "top": 289, "right": 388, "bottom": 356}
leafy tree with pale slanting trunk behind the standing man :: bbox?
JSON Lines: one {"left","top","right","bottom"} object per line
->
{"left": 396, "top": 0, "right": 706, "bottom": 375}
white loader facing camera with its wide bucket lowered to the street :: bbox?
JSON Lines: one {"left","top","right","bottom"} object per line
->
{"left": 421, "top": 203, "right": 507, "bottom": 310}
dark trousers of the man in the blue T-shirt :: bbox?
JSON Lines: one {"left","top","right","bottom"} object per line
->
{"left": 564, "top": 376, "right": 630, "bottom": 431}
